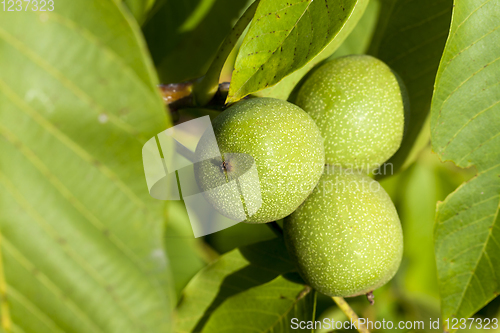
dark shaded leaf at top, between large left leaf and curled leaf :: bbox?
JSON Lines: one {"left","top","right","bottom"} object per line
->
{"left": 144, "top": 0, "right": 252, "bottom": 83}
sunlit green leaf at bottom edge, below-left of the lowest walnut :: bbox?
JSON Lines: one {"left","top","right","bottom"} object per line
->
{"left": 203, "top": 276, "right": 315, "bottom": 333}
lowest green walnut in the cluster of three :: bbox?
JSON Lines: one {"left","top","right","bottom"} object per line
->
{"left": 283, "top": 166, "right": 403, "bottom": 297}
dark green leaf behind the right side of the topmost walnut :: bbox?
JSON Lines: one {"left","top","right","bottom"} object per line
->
{"left": 368, "top": 0, "right": 453, "bottom": 171}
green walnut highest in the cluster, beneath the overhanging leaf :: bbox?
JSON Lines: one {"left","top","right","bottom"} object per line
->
{"left": 296, "top": 55, "right": 404, "bottom": 170}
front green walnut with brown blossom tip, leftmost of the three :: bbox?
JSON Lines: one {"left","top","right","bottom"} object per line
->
{"left": 196, "top": 98, "right": 325, "bottom": 223}
